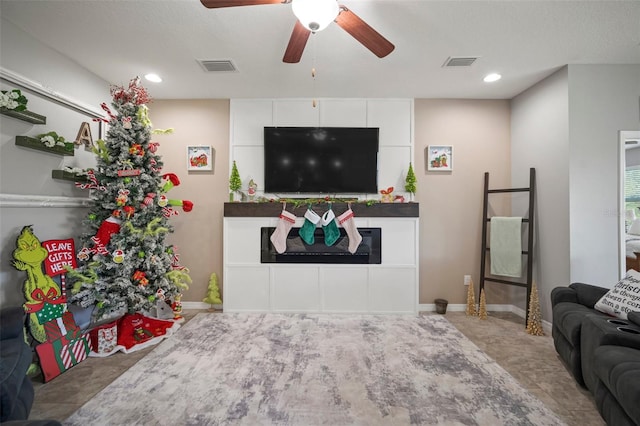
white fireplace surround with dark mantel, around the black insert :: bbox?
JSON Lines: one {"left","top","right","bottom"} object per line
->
{"left": 223, "top": 202, "right": 419, "bottom": 314}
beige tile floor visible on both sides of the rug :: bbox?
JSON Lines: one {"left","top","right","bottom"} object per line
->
{"left": 29, "top": 311, "right": 605, "bottom": 426}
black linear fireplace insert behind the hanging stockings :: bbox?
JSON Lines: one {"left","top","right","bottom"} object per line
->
{"left": 260, "top": 227, "right": 382, "bottom": 264}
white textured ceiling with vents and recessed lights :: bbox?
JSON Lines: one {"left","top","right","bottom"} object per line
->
{"left": 0, "top": 0, "right": 640, "bottom": 99}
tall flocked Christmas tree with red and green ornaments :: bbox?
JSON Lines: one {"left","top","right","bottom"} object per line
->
{"left": 68, "top": 78, "right": 193, "bottom": 319}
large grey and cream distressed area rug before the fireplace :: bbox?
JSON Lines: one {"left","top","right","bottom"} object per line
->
{"left": 64, "top": 314, "right": 564, "bottom": 426}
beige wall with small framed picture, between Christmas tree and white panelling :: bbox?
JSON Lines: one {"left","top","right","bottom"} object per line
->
{"left": 149, "top": 100, "right": 230, "bottom": 302}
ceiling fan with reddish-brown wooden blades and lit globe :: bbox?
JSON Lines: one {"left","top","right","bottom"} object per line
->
{"left": 200, "top": 0, "right": 395, "bottom": 64}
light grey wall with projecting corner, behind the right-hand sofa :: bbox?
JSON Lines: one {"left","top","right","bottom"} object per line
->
{"left": 511, "top": 65, "right": 640, "bottom": 321}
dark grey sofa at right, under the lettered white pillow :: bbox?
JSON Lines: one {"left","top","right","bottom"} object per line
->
{"left": 551, "top": 283, "right": 640, "bottom": 426}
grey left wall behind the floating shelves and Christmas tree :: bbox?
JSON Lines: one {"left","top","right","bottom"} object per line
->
{"left": 0, "top": 20, "right": 109, "bottom": 307}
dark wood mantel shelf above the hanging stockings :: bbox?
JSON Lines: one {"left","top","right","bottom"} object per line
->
{"left": 224, "top": 201, "right": 419, "bottom": 217}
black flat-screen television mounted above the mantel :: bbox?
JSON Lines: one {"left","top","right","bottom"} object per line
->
{"left": 264, "top": 127, "right": 379, "bottom": 194}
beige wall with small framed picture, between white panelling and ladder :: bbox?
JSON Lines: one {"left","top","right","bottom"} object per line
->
{"left": 414, "top": 99, "right": 511, "bottom": 304}
